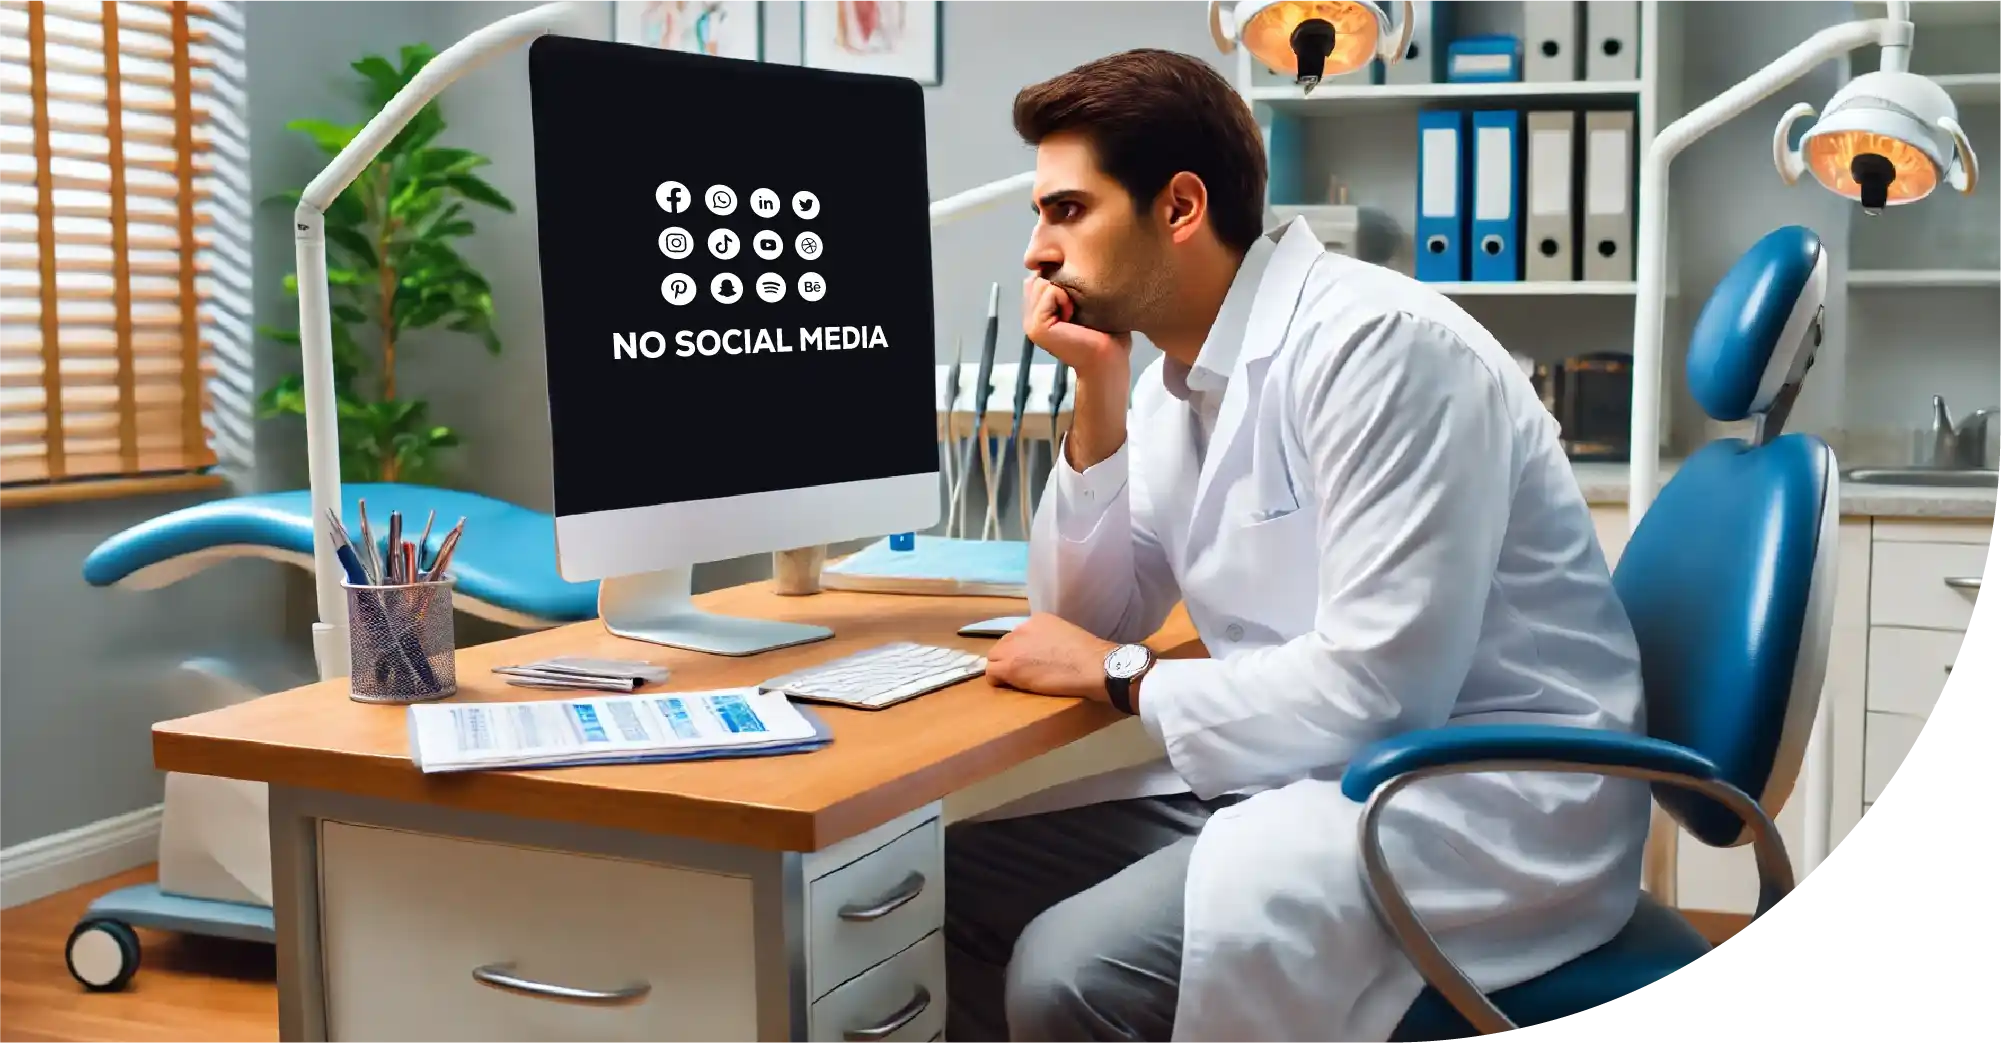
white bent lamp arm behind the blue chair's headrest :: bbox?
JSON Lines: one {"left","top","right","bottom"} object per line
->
{"left": 1628, "top": 18, "right": 1912, "bottom": 531}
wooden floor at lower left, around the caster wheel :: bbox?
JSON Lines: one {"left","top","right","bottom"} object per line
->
{"left": 0, "top": 866, "right": 278, "bottom": 1044}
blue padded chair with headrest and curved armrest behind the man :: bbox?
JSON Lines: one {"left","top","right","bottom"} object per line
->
{"left": 1341, "top": 226, "right": 1840, "bottom": 1044}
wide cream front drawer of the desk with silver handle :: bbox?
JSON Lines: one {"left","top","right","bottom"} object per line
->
{"left": 320, "top": 822, "right": 757, "bottom": 1044}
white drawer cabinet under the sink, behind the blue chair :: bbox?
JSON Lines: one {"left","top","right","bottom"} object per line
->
{"left": 1592, "top": 505, "right": 1996, "bottom": 914}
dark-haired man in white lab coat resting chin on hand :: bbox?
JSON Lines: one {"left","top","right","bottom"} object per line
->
{"left": 945, "top": 50, "right": 1648, "bottom": 1044}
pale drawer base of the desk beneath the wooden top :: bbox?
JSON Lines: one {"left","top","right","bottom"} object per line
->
{"left": 288, "top": 788, "right": 947, "bottom": 1044}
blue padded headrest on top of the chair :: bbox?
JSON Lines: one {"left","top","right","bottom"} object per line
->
{"left": 1688, "top": 224, "right": 1828, "bottom": 445}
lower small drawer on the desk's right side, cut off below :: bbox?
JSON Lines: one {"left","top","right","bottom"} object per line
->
{"left": 804, "top": 932, "right": 945, "bottom": 1044}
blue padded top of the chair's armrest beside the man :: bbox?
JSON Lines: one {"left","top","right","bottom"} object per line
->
{"left": 1341, "top": 725, "right": 1722, "bottom": 802}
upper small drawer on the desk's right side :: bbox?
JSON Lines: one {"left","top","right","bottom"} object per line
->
{"left": 807, "top": 820, "right": 945, "bottom": 998}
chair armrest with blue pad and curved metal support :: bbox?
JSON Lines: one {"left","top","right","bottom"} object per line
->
{"left": 1341, "top": 725, "right": 1796, "bottom": 1040}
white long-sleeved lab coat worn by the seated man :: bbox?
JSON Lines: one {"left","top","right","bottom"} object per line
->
{"left": 1031, "top": 220, "right": 1648, "bottom": 1044}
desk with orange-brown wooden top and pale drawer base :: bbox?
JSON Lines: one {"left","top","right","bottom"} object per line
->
{"left": 154, "top": 583, "right": 1203, "bottom": 1044}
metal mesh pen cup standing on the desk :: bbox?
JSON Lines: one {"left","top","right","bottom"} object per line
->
{"left": 352, "top": 577, "right": 458, "bottom": 703}
